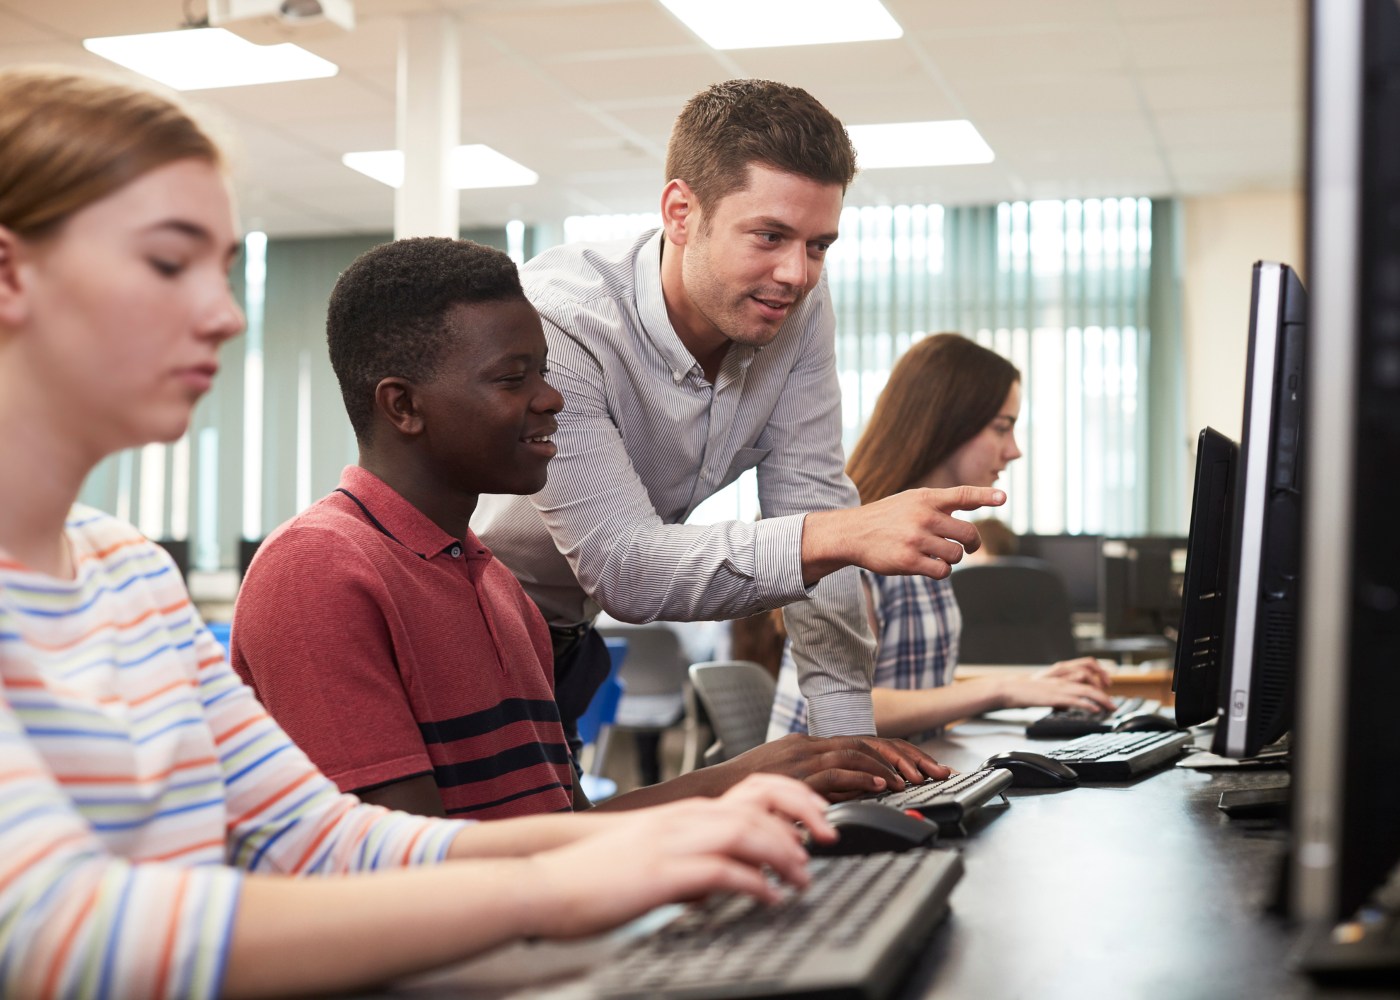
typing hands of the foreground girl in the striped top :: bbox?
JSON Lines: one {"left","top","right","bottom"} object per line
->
{"left": 521, "top": 775, "right": 836, "bottom": 937}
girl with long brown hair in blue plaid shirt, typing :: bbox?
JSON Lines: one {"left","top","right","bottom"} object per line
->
{"left": 769, "top": 333, "right": 1113, "bottom": 739}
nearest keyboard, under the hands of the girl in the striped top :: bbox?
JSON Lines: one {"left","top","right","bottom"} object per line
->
{"left": 588, "top": 849, "right": 963, "bottom": 1000}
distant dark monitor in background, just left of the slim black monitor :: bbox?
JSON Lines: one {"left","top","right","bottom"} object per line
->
{"left": 1099, "top": 535, "right": 1187, "bottom": 639}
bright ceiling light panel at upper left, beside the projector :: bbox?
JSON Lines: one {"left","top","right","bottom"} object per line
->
{"left": 83, "top": 28, "right": 340, "bottom": 90}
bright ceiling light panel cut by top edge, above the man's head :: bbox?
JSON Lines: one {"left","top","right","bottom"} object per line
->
{"left": 661, "top": 0, "right": 904, "bottom": 49}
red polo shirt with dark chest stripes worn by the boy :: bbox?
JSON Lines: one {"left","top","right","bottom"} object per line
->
{"left": 232, "top": 466, "right": 573, "bottom": 819}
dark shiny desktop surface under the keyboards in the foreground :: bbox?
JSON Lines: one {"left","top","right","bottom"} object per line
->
{"left": 393, "top": 720, "right": 1379, "bottom": 1000}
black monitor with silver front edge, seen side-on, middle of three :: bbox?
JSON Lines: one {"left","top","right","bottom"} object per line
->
{"left": 1212, "top": 262, "right": 1308, "bottom": 758}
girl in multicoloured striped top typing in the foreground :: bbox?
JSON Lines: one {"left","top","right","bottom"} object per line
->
{"left": 0, "top": 70, "right": 834, "bottom": 997}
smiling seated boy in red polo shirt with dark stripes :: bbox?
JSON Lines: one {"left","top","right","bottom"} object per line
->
{"left": 232, "top": 238, "right": 946, "bottom": 818}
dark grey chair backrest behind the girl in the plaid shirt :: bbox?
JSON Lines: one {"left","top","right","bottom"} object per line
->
{"left": 949, "top": 556, "right": 1075, "bottom": 664}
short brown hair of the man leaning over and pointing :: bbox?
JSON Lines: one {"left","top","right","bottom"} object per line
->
{"left": 666, "top": 80, "right": 855, "bottom": 206}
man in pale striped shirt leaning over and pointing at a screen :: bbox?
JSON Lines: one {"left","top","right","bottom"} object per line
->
{"left": 472, "top": 80, "right": 1005, "bottom": 735}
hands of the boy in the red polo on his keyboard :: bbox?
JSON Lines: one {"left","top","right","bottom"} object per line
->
{"left": 717, "top": 732, "right": 951, "bottom": 801}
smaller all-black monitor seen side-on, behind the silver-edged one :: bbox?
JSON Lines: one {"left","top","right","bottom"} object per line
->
{"left": 1172, "top": 427, "right": 1239, "bottom": 725}
